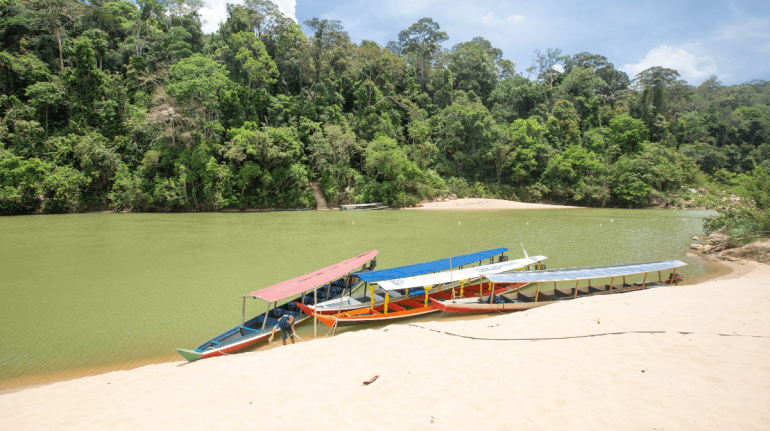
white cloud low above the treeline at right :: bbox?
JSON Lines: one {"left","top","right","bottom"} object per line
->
{"left": 620, "top": 44, "right": 717, "bottom": 81}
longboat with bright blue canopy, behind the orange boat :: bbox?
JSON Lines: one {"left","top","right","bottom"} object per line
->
{"left": 303, "top": 247, "right": 508, "bottom": 315}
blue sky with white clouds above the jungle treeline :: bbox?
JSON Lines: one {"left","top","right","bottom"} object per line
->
{"left": 196, "top": 0, "right": 770, "bottom": 85}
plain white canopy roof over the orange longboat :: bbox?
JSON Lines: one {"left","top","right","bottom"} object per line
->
{"left": 377, "top": 256, "right": 546, "bottom": 290}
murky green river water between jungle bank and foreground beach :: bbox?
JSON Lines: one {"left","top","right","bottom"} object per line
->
{"left": 0, "top": 209, "right": 714, "bottom": 389}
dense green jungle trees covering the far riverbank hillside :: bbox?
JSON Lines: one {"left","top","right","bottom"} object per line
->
{"left": 0, "top": 0, "right": 770, "bottom": 214}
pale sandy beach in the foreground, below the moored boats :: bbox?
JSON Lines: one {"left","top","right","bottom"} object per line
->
{"left": 0, "top": 264, "right": 770, "bottom": 430}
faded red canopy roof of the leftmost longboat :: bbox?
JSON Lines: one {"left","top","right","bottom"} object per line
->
{"left": 243, "top": 250, "right": 379, "bottom": 302}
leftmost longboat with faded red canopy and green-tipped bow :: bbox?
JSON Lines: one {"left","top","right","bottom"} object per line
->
{"left": 177, "top": 250, "right": 379, "bottom": 362}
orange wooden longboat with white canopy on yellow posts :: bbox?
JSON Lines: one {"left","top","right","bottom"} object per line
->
{"left": 297, "top": 256, "right": 545, "bottom": 327}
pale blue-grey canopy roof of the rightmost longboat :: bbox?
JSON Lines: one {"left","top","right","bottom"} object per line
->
{"left": 484, "top": 260, "right": 687, "bottom": 283}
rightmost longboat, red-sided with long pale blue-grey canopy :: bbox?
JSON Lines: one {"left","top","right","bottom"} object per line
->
{"left": 431, "top": 260, "right": 686, "bottom": 313}
